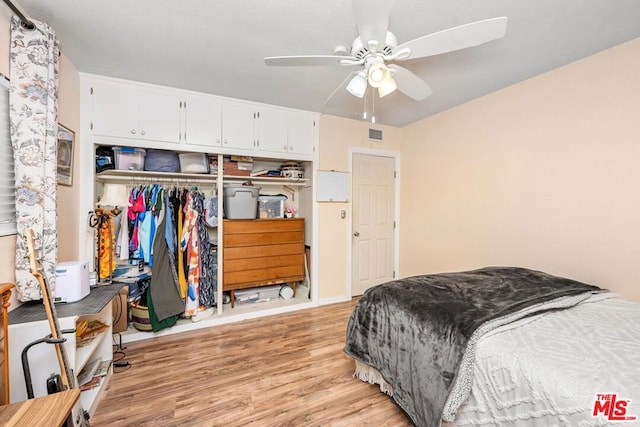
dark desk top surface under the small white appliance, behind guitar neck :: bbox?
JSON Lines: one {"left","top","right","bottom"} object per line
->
{"left": 9, "top": 282, "right": 126, "bottom": 325}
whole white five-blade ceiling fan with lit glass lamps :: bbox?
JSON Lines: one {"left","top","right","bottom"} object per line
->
{"left": 264, "top": 0, "right": 507, "bottom": 105}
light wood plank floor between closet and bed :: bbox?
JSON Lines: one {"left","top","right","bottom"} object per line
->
{"left": 91, "top": 302, "right": 412, "bottom": 427}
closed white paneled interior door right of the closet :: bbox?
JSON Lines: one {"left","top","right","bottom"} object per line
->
{"left": 351, "top": 154, "right": 395, "bottom": 295}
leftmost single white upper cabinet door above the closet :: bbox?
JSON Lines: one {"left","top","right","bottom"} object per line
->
{"left": 91, "top": 82, "right": 139, "bottom": 138}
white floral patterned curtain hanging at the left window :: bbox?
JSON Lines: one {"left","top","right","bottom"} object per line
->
{"left": 9, "top": 16, "right": 59, "bottom": 302}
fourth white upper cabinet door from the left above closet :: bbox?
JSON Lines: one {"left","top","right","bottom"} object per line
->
{"left": 222, "top": 103, "right": 255, "bottom": 151}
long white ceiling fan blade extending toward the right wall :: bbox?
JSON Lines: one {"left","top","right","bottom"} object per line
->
{"left": 393, "top": 16, "right": 507, "bottom": 59}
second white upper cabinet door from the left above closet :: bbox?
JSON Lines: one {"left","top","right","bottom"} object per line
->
{"left": 138, "top": 90, "right": 180, "bottom": 142}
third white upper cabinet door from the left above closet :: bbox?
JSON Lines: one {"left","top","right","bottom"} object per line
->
{"left": 182, "top": 95, "right": 222, "bottom": 147}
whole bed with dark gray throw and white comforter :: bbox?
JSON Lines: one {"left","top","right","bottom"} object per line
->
{"left": 344, "top": 267, "right": 640, "bottom": 426}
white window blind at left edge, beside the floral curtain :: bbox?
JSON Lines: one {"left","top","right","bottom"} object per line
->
{"left": 0, "top": 74, "right": 16, "bottom": 236}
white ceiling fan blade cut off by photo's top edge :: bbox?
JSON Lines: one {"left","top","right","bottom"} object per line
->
{"left": 353, "top": 0, "right": 391, "bottom": 50}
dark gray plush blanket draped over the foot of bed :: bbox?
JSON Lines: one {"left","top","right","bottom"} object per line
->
{"left": 344, "top": 267, "right": 602, "bottom": 426}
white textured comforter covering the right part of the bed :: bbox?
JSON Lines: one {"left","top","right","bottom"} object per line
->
{"left": 450, "top": 294, "right": 640, "bottom": 427}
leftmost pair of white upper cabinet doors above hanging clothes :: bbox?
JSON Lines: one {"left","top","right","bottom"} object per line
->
{"left": 91, "top": 78, "right": 180, "bottom": 142}
